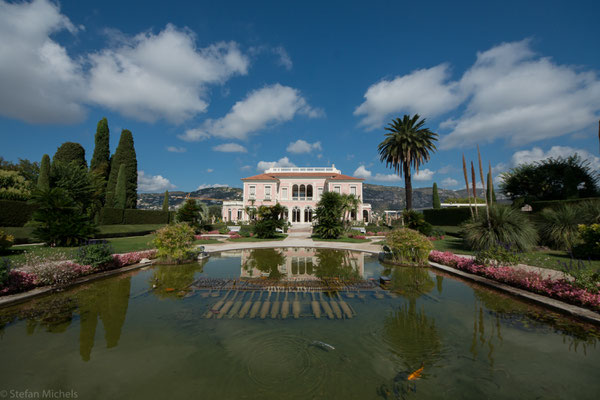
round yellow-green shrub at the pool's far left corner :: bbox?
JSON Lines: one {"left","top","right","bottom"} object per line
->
{"left": 152, "top": 223, "right": 195, "bottom": 263}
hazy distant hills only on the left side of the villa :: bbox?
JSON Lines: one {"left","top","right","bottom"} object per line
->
{"left": 138, "top": 187, "right": 242, "bottom": 210}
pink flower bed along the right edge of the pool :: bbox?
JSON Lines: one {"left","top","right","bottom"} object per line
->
{"left": 429, "top": 250, "right": 600, "bottom": 311}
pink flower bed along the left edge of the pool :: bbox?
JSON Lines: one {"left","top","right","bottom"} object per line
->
{"left": 0, "top": 250, "right": 156, "bottom": 296}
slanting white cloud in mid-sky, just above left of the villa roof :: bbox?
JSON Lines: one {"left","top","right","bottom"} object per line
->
{"left": 179, "top": 83, "right": 322, "bottom": 141}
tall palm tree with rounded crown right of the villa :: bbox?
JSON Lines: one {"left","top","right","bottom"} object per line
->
{"left": 377, "top": 114, "right": 438, "bottom": 210}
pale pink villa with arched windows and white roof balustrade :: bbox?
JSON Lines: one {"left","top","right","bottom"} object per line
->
{"left": 223, "top": 165, "right": 371, "bottom": 225}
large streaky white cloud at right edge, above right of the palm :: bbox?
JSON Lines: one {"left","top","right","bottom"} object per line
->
{"left": 441, "top": 40, "right": 600, "bottom": 148}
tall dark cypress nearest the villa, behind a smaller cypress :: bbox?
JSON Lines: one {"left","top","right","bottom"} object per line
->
{"left": 106, "top": 129, "right": 137, "bottom": 208}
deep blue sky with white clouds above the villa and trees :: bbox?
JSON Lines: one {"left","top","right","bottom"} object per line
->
{"left": 0, "top": 0, "right": 600, "bottom": 191}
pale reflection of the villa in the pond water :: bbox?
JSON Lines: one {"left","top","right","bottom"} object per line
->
{"left": 240, "top": 247, "right": 365, "bottom": 281}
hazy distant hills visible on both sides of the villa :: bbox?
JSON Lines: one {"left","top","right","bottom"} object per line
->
{"left": 138, "top": 183, "right": 502, "bottom": 212}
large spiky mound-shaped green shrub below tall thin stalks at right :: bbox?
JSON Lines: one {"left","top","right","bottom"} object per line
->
{"left": 463, "top": 205, "right": 538, "bottom": 251}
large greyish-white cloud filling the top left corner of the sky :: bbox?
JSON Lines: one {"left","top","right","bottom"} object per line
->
{"left": 0, "top": 0, "right": 86, "bottom": 124}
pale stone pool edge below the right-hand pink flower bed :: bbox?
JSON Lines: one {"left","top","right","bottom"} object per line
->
{"left": 429, "top": 261, "right": 600, "bottom": 325}
